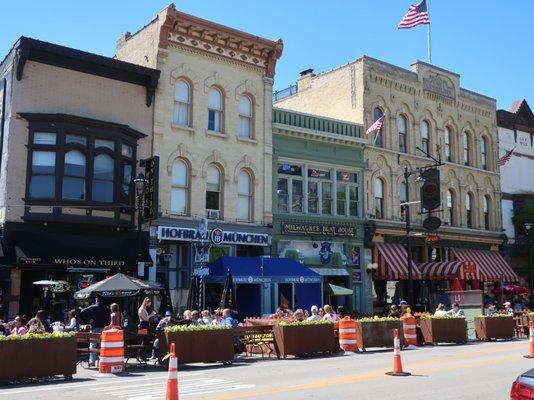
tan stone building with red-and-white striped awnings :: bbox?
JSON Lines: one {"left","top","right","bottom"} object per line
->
{"left": 275, "top": 56, "right": 515, "bottom": 312}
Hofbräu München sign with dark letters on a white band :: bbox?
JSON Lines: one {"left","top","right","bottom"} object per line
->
{"left": 158, "top": 226, "right": 271, "bottom": 246}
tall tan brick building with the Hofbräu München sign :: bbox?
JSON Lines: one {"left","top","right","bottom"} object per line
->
{"left": 117, "top": 4, "right": 283, "bottom": 306}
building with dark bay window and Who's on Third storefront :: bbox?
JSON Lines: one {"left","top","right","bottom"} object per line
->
{"left": 0, "top": 37, "right": 159, "bottom": 320}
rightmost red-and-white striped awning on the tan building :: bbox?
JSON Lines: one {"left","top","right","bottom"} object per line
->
{"left": 451, "top": 248, "right": 519, "bottom": 282}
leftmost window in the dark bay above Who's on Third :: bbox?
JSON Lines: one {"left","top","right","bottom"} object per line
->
{"left": 30, "top": 151, "right": 56, "bottom": 199}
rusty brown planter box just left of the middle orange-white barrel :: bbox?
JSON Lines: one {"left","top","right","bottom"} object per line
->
{"left": 273, "top": 324, "right": 336, "bottom": 358}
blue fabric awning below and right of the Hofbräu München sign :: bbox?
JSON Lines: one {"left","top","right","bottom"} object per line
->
{"left": 204, "top": 256, "right": 323, "bottom": 283}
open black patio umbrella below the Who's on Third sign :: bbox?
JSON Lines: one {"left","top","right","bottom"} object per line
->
{"left": 74, "top": 272, "right": 165, "bottom": 299}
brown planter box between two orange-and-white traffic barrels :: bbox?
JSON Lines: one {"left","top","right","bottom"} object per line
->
{"left": 356, "top": 320, "right": 404, "bottom": 350}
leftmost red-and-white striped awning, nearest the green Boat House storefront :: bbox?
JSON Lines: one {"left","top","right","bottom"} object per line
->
{"left": 376, "top": 243, "right": 421, "bottom": 280}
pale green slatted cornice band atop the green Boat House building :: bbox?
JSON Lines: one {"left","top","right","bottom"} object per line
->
{"left": 273, "top": 108, "right": 362, "bottom": 138}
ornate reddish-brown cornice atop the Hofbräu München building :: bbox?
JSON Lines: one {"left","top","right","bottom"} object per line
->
{"left": 158, "top": 4, "right": 284, "bottom": 78}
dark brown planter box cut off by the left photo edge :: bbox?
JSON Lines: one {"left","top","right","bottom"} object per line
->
{"left": 0, "top": 337, "right": 77, "bottom": 382}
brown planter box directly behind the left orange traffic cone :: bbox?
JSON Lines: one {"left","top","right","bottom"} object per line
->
{"left": 165, "top": 329, "right": 234, "bottom": 364}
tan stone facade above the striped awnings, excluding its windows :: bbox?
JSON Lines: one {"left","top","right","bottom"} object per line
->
{"left": 275, "top": 56, "right": 502, "bottom": 248}
